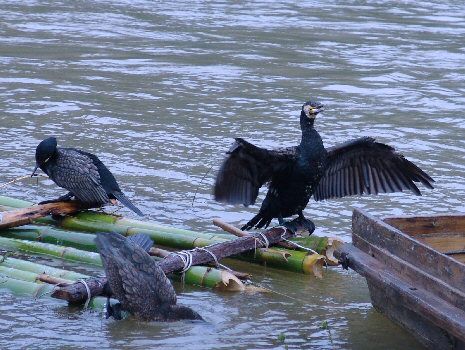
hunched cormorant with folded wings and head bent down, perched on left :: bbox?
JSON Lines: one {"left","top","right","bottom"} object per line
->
{"left": 31, "top": 137, "right": 144, "bottom": 216}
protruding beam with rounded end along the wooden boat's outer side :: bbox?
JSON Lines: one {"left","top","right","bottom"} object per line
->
{"left": 337, "top": 244, "right": 465, "bottom": 342}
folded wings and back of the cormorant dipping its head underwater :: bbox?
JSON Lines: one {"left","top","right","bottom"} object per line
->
{"left": 96, "top": 233, "right": 176, "bottom": 316}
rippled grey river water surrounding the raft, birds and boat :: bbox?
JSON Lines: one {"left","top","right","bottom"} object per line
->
{"left": 0, "top": 1, "right": 465, "bottom": 349}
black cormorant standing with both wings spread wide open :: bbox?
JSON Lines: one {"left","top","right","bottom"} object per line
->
{"left": 214, "top": 101, "right": 434, "bottom": 233}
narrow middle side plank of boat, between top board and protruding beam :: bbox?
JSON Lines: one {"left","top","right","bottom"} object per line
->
{"left": 352, "top": 233, "right": 465, "bottom": 311}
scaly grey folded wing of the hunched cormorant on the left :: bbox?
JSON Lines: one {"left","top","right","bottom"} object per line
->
{"left": 49, "top": 148, "right": 109, "bottom": 203}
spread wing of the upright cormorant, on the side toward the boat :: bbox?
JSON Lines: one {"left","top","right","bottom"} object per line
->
{"left": 313, "top": 137, "right": 434, "bottom": 201}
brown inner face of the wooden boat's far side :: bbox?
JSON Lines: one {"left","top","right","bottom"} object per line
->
{"left": 383, "top": 213, "right": 465, "bottom": 235}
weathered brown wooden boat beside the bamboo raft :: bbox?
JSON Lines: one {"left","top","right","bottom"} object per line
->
{"left": 340, "top": 210, "right": 465, "bottom": 349}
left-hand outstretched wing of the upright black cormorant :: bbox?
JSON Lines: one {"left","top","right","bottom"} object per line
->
{"left": 213, "top": 138, "right": 296, "bottom": 206}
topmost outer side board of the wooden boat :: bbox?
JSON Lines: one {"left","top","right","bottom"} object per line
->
{"left": 352, "top": 209, "right": 465, "bottom": 292}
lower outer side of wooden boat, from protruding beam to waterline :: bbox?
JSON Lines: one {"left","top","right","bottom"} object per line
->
{"left": 337, "top": 244, "right": 465, "bottom": 349}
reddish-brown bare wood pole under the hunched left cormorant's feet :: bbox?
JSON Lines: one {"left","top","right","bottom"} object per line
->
{"left": 0, "top": 201, "right": 89, "bottom": 229}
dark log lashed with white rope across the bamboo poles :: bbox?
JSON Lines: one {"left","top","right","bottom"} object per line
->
{"left": 52, "top": 228, "right": 292, "bottom": 303}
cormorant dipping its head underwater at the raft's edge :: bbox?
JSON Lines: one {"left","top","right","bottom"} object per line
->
{"left": 95, "top": 233, "right": 202, "bottom": 321}
